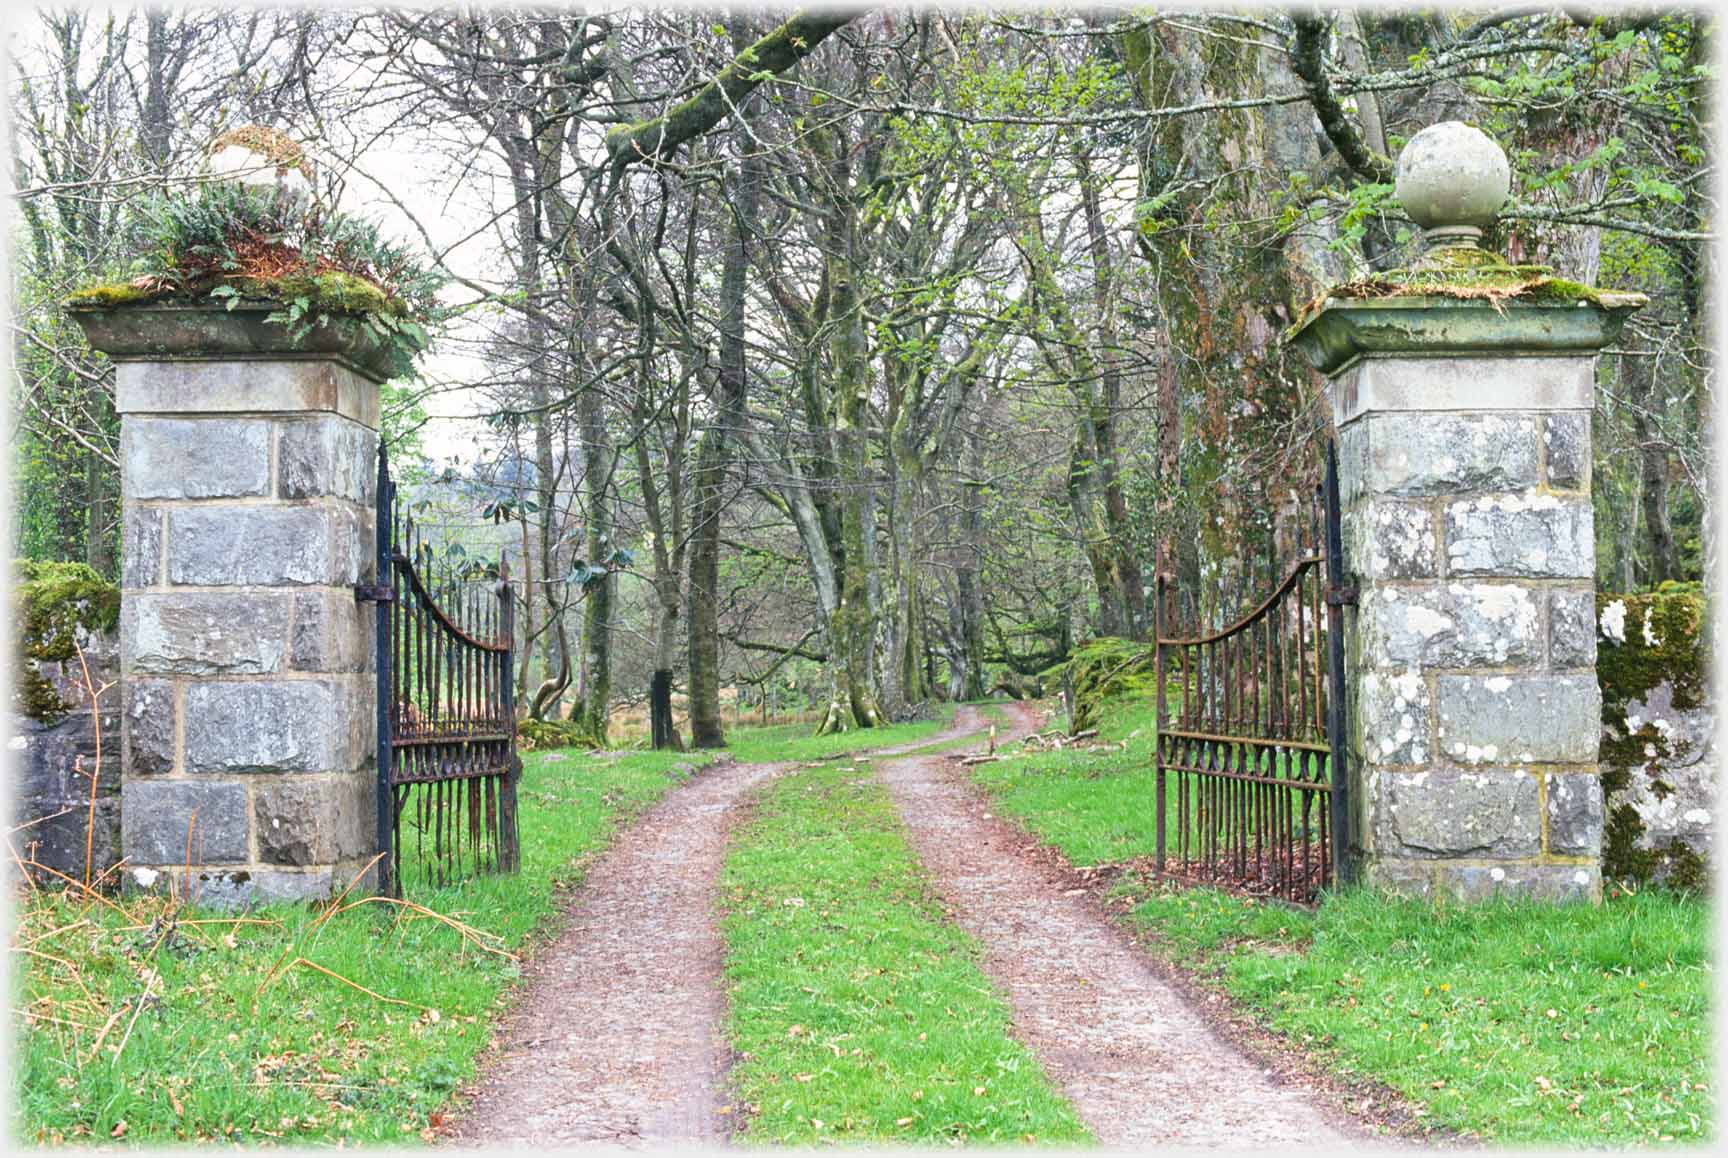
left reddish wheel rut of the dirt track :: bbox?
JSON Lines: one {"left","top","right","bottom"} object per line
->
{"left": 446, "top": 764, "right": 778, "bottom": 1146}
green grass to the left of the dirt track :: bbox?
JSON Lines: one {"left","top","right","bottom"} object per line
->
{"left": 12, "top": 752, "right": 703, "bottom": 1144}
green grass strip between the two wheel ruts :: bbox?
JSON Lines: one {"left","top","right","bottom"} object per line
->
{"left": 722, "top": 764, "right": 1087, "bottom": 1144}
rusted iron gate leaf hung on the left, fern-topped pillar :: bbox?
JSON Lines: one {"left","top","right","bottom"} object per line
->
{"left": 358, "top": 448, "right": 522, "bottom": 897}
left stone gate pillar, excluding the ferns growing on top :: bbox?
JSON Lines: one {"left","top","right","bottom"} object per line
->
{"left": 74, "top": 306, "right": 384, "bottom": 904}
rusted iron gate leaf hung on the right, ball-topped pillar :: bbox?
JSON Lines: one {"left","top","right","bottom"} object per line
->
{"left": 1154, "top": 442, "right": 1355, "bottom": 904}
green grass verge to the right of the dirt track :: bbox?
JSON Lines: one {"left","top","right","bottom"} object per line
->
{"left": 973, "top": 702, "right": 1714, "bottom": 1144}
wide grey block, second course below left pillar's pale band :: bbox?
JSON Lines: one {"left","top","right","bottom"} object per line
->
{"left": 168, "top": 506, "right": 342, "bottom": 588}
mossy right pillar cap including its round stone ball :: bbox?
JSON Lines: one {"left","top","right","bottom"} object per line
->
{"left": 1284, "top": 121, "right": 1647, "bottom": 377}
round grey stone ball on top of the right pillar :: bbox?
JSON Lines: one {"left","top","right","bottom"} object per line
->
{"left": 1393, "top": 121, "right": 1512, "bottom": 245}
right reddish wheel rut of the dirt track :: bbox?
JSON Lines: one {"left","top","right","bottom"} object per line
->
{"left": 878, "top": 705, "right": 1360, "bottom": 1151}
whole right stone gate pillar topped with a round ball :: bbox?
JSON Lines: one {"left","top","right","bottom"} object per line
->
{"left": 1289, "top": 121, "right": 1643, "bottom": 900}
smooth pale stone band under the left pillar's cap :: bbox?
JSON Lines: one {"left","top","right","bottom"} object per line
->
{"left": 114, "top": 358, "right": 378, "bottom": 430}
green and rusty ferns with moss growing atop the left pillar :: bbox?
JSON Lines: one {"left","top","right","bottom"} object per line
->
{"left": 67, "top": 181, "right": 444, "bottom": 377}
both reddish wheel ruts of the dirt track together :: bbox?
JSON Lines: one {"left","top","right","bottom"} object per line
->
{"left": 442, "top": 703, "right": 1362, "bottom": 1151}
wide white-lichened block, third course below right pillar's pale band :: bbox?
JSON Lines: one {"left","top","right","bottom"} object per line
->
{"left": 1358, "top": 582, "right": 1541, "bottom": 667}
